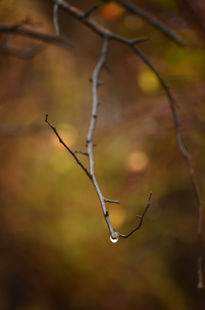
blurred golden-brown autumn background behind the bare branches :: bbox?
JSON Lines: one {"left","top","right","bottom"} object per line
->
{"left": 0, "top": 0, "right": 205, "bottom": 310}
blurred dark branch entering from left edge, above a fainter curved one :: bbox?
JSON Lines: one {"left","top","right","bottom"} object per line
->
{"left": 0, "top": 24, "right": 74, "bottom": 48}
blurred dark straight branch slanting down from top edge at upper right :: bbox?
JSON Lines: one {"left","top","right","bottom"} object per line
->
{"left": 102, "top": 0, "right": 186, "bottom": 46}
